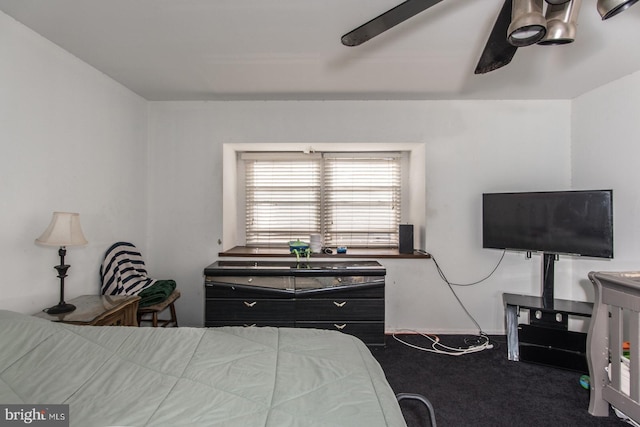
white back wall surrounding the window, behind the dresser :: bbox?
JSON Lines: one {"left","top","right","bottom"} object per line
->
{"left": 149, "top": 101, "right": 571, "bottom": 332}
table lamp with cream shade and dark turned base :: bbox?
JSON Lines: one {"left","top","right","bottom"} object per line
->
{"left": 36, "top": 212, "right": 87, "bottom": 314}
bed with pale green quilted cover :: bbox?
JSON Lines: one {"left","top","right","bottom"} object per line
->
{"left": 0, "top": 310, "right": 406, "bottom": 427}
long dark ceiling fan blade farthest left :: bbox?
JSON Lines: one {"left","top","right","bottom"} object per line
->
{"left": 341, "top": 0, "right": 444, "bottom": 46}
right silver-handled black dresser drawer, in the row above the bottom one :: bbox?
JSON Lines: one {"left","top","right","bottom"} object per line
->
{"left": 296, "top": 298, "right": 384, "bottom": 320}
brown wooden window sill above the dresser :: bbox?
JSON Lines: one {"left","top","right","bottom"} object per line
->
{"left": 218, "top": 246, "right": 431, "bottom": 259}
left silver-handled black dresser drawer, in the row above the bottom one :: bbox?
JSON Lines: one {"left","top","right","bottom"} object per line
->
{"left": 205, "top": 299, "right": 295, "bottom": 324}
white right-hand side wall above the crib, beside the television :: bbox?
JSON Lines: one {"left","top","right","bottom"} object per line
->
{"left": 571, "top": 68, "right": 640, "bottom": 301}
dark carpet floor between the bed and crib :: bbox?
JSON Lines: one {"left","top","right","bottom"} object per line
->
{"left": 371, "top": 335, "right": 629, "bottom": 427}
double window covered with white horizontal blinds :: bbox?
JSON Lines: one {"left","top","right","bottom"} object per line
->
{"left": 241, "top": 152, "right": 402, "bottom": 248}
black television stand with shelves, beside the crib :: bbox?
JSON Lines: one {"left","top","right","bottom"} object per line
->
{"left": 502, "top": 293, "right": 593, "bottom": 373}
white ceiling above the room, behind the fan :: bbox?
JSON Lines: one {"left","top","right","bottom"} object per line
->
{"left": 0, "top": 0, "right": 640, "bottom": 101}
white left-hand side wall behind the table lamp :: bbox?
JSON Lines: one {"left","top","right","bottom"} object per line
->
{"left": 0, "top": 12, "right": 147, "bottom": 313}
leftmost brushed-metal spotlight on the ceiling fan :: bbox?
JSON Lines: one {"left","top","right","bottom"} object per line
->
{"left": 507, "top": 0, "right": 547, "bottom": 47}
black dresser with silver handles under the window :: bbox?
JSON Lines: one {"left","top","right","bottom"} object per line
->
{"left": 204, "top": 261, "right": 386, "bottom": 345}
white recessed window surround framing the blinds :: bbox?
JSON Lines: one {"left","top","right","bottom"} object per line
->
{"left": 220, "top": 142, "right": 424, "bottom": 259}
